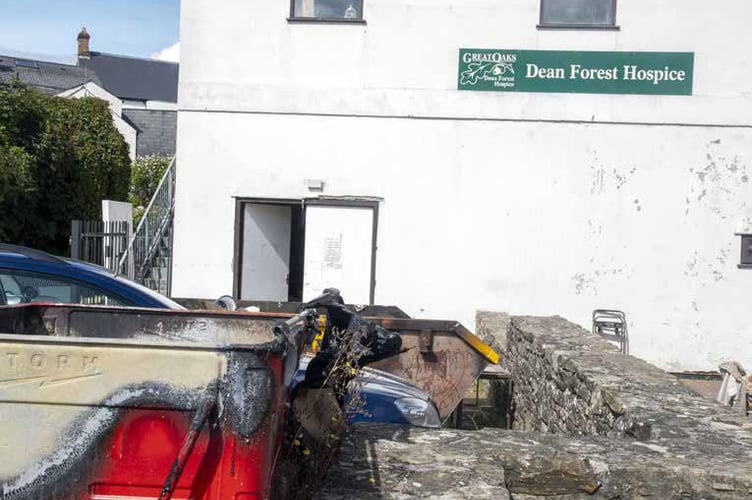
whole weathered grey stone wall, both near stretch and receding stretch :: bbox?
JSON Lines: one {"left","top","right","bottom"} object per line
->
{"left": 316, "top": 317, "right": 752, "bottom": 500}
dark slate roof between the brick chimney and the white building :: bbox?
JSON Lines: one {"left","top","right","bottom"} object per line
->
{"left": 78, "top": 52, "right": 179, "bottom": 102}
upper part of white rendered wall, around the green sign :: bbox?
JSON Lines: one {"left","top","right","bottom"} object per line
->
{"left": 179, "top": 0, "right": 752, "bottom": 125}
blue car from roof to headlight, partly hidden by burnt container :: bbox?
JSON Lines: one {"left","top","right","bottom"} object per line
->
{"left": 0, "top": 243, "right": 441, "bottom": 427}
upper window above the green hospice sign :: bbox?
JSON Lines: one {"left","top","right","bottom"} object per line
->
{"left": 540, "top": 0, "right": 616, "bottom": 28}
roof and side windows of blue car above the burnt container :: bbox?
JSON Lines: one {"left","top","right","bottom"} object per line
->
{"left": 0, "top": 243, "right": 184, "bottom": 309}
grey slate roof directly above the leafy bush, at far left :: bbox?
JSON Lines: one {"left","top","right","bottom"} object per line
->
{"left": 0, "top": 55, "right": 102, "bottom": 95}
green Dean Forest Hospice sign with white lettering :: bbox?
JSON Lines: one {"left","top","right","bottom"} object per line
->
{"left": 457, "top": 49, "right": 695, "bottom": 95}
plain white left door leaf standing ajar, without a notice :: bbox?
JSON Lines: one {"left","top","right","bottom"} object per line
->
{"left": 240, "top": 203, "right": 292, "bottom": 301}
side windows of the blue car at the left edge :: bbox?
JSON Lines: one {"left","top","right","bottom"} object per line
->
{"left": 0, "top": 271, "right": 129, "bottom": 306}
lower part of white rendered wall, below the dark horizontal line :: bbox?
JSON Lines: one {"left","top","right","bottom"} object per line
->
{"left": 174, "top": 113, "right": 752, "bottom": 369}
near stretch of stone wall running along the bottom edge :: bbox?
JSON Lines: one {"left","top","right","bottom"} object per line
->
{"left": 314, "top": 424, "right": 752, "bottom": 500}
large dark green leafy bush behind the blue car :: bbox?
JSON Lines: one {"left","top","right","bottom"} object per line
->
{"left": 0, "top": 84, "right": 130, "bottom": 255}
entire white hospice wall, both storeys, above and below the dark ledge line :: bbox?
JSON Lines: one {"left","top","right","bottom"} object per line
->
{"left": 173, "top": 0, "right": 752, "bottom": 369}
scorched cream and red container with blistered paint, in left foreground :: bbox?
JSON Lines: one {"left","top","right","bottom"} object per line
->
{"left": 0, "top": 305, "right": 313, "bottom": 500}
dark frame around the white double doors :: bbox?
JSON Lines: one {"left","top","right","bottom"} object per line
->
{"left": 232, "top": 196, "right": 379, "bottom": 305}
